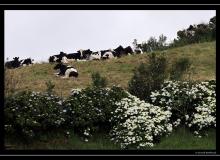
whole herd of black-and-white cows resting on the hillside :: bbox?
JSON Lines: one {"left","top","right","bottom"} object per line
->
{"left": 5, "top": 45, "right": 143, "bottom": 78}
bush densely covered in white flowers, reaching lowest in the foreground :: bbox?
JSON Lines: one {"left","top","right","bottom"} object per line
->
{"left": 110, "top": 95, "right": 172, "bottom": 149}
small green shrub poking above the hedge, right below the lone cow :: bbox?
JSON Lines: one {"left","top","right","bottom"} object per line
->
{"left": 92, "top": 72, "right": 107, "bottom": 88}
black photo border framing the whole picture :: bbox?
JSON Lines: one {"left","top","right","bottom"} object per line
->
{"left": 0, "top": 4, "right": 220, "bottom": 157}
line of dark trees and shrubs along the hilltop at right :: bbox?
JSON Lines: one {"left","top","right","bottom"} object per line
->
{"left": 133, "top": 16, "right": 216, "bottom": 52}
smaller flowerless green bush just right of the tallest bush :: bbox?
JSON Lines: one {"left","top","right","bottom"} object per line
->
{"left": 170, "top": 58, "right": 191, "bottom": 80}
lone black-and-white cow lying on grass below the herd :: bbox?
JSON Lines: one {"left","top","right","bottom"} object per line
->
{"left": 54, "top": 63, "right": 79, "bottom": 78}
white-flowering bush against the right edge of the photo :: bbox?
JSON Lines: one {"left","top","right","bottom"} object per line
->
{"left": 151, "top": 80, "right": 216, "bottom": 135}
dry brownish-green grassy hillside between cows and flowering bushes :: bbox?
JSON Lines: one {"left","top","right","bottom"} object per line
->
{"left": 5, "top": 42, "right": 216, "bottom": 96}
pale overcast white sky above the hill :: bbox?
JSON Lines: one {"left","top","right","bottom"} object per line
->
{"left": 5, "top": 10, "right": 216, "bottom": 62}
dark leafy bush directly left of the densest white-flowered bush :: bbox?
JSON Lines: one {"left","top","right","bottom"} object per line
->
{"left": 64, "top": 86, "right": 127, "bottom": 139}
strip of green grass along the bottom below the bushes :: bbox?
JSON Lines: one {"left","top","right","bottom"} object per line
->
{"left": 5, "top": 128, "right": 216, "bottom": 150}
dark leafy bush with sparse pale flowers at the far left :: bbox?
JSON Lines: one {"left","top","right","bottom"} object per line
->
{"left": 4, "top": 91, "right": 65, "bottom": 139}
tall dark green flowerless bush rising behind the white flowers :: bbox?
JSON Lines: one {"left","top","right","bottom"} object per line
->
{"left": 128, "top": 53, "right": 167, "bottom": 101}
